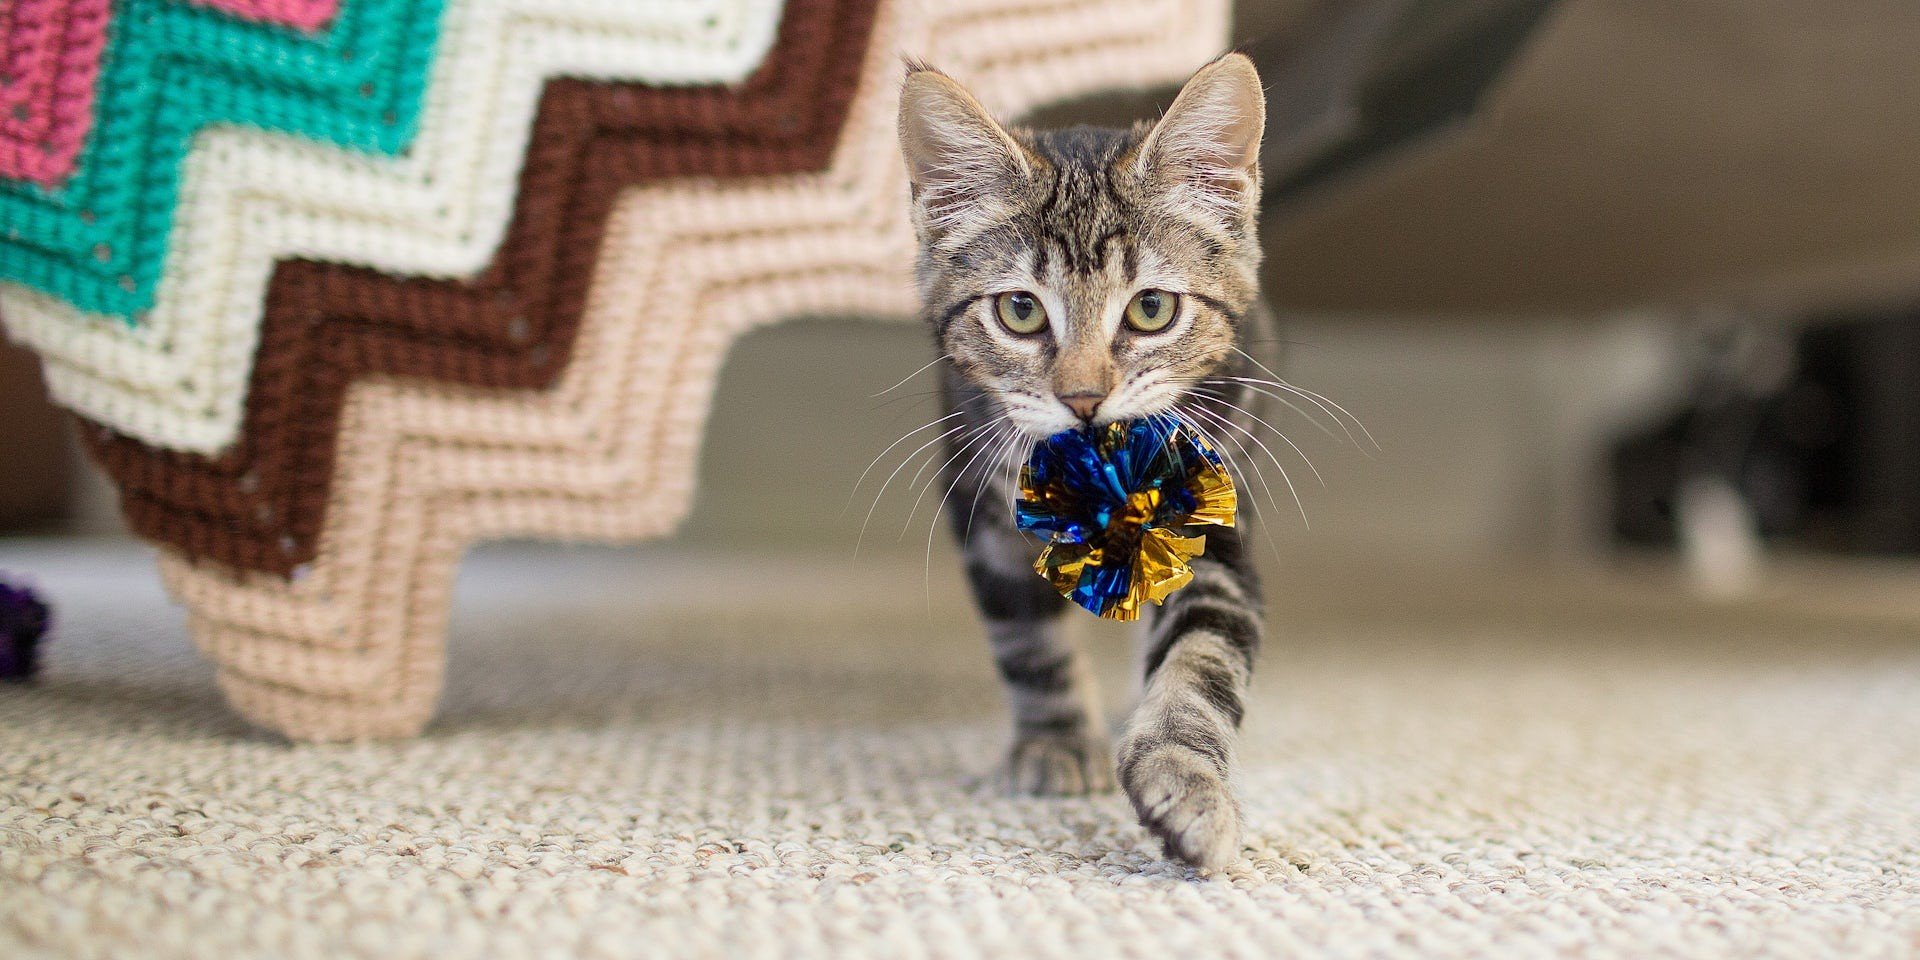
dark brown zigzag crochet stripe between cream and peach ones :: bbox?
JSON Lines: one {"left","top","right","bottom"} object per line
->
{"left": 84, "top": 0, "right": 877, "bottom": 576}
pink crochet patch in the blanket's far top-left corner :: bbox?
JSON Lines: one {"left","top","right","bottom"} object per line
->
{"left": 0, "top": 0, "right": 108, "bottom": 186}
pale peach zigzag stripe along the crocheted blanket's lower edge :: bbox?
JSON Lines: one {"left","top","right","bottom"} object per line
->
{"left": 163, "top": 0, "right": 1227, "bottom": 739}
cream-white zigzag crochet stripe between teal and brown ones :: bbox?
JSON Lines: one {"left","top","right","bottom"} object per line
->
{"left": 0, "top": 0, "right": 780, "bottom": 453}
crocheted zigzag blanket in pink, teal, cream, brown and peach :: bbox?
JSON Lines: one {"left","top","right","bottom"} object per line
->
{"left": 0, "top": 0, "right": 1227, "bottom": 737}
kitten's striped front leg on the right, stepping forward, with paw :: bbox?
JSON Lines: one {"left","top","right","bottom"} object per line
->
{"left": 1119, "top": 530, "right": 1261, "bottom": 870}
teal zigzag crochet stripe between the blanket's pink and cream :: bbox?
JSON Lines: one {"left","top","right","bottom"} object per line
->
{"left": 0, "top": 0, "right": 444, "bottom": 323}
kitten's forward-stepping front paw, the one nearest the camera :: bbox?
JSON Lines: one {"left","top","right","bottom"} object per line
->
{"left": 1119, "top": 743, "right": 1240, "bottom": 872}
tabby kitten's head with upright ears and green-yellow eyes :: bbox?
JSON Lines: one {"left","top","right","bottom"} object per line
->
{"left": 900, "top": 54, "right": 1265, "bottom": 438}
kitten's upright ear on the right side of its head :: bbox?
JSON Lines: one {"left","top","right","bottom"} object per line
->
{"left": 1133, "top": 54, "right": 1267, "bottom": 225}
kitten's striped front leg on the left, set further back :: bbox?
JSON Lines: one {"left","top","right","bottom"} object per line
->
{"left": 962, "top": 524, "right": 1114, "bottom": 795}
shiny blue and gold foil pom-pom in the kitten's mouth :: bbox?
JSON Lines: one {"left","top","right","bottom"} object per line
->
{"left": 1016, "top": 417, "right": 1236, "bottom": 620}
